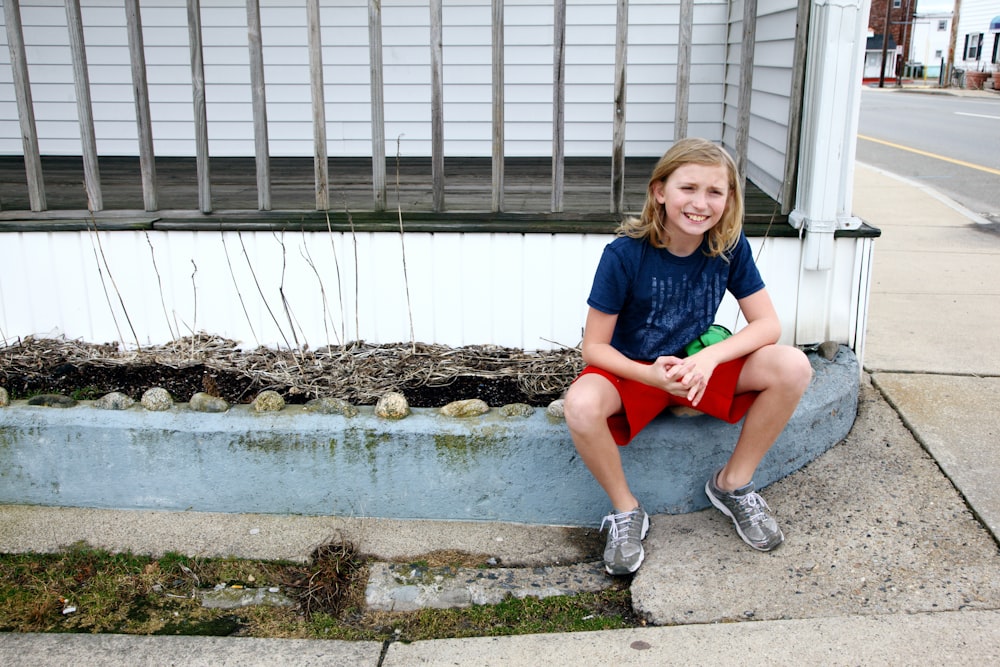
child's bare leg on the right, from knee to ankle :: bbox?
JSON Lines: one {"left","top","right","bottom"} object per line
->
{"left": 716, "top": 345, "right": 812, "bottom": 491}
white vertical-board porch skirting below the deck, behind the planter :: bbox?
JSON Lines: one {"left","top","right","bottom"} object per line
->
{"left": 0, "top": 231, "right": 871, "bottom": 350}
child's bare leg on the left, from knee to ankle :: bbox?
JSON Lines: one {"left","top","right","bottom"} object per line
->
{"left": 564, "top": 373, "right": 639, "bottom": 512}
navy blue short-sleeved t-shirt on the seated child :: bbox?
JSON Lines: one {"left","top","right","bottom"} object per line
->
{"left": 587, "top": 233, "right": 764, "bottom": 361}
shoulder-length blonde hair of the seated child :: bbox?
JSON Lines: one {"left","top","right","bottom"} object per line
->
{"left": 616, "top": 138, "right": 743, "bottom": 257}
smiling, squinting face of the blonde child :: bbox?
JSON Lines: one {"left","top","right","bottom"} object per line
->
{"left": 653, "top": 163, "right": 729, "bottom": 252}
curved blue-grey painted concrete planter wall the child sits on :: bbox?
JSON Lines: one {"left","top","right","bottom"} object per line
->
{"left": 0, "top": 347, "right": 860, "bottom": 525}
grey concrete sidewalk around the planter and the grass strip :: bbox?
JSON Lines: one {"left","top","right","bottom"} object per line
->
{"left": 0, "top": 160, "right": 1000, "bottom": 666}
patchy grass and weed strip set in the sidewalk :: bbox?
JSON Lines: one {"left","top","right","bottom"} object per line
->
{"left": 0, "top": 542, "right": 643, "bottom": 641}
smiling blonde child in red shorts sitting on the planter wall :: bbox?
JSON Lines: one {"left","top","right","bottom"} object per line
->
{"left": 565, "top": 139, "right": 812, "bottom": 574}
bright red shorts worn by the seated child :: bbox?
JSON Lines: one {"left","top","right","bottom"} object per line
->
{"left": 580, "top": 357, "right": 757, "bottom": 445}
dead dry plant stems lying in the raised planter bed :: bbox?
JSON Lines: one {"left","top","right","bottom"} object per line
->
{"left": 0, "top": 334, "right": 583, "bottom": 405}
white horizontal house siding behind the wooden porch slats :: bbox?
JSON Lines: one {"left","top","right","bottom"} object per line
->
{"left": 0, "top": 0, "right": 795, "bottom": 176}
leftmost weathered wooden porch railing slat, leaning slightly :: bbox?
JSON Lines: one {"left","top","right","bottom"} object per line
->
{"left": 3, "top": 0, "right": 47, "bottom": 211}
